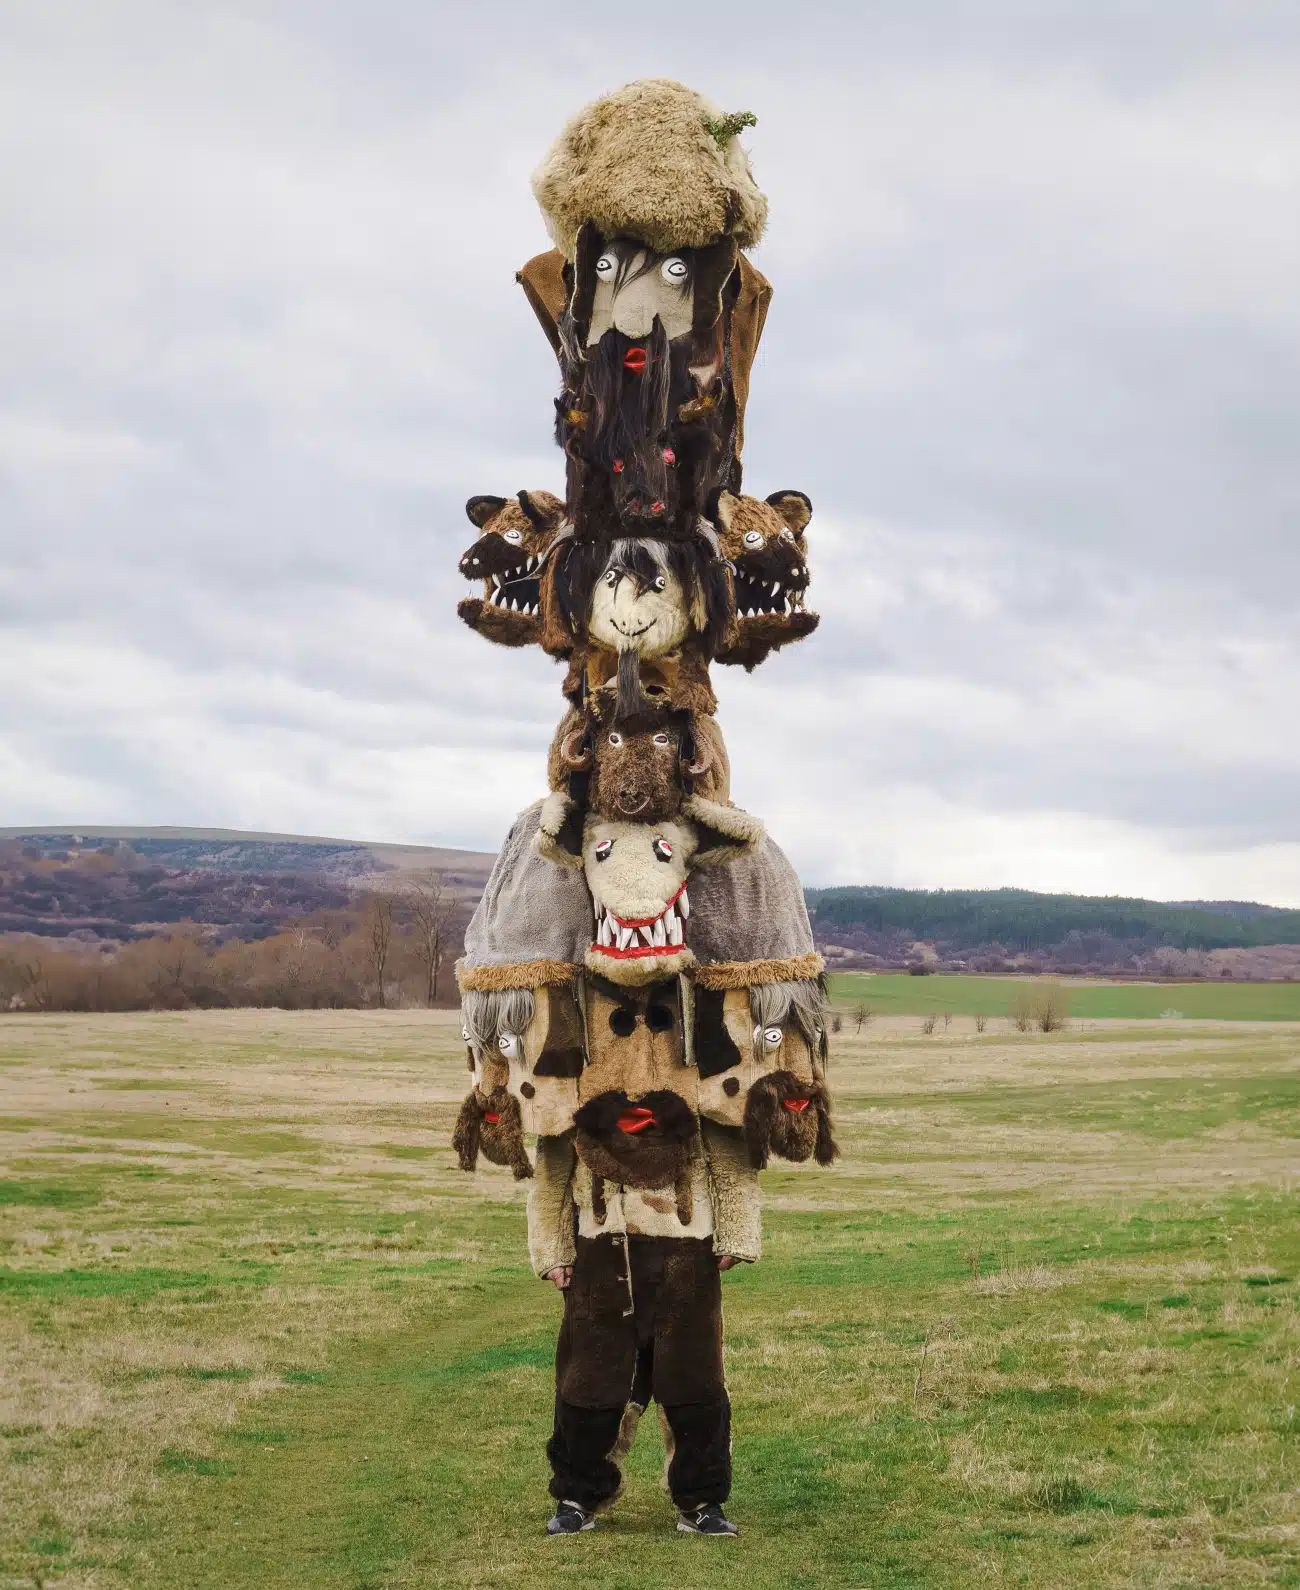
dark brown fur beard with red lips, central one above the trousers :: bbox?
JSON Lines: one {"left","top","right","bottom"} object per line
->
{"left": 574, "top": 1088, "right": 698, "bottom": 1226}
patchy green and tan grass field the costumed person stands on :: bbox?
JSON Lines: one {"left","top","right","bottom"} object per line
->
{"left": 0, "top": 1011, "right": 1300, "bottom": 1590}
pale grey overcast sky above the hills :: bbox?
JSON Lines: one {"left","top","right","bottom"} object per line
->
{"left": 0, "top": 0, "right": 1300, "bottom": 905}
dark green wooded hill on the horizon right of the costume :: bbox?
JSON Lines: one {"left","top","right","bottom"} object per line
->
{"left": 806, "top": 886, "right": 1300, "bottom": 954}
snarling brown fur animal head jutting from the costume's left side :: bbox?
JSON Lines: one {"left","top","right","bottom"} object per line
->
{"left": 456, "top": 491, "right": 564, "bottom": 646}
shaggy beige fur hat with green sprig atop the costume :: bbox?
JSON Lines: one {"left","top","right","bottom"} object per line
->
{"left": 532, "top": 78, "right": 768, "bottom": 259}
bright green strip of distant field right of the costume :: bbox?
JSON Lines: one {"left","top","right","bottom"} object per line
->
{"left": 831, "top": 971, "right": 1300, "bottom": 1021}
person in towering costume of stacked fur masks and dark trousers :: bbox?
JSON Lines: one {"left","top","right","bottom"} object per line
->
{"left": 455, "top": 78, "right": 836, "bottom": 1511}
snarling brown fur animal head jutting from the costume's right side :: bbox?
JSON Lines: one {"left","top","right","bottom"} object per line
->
{"left": 717, "top": 491, "right": 820, "bottom": 669}
